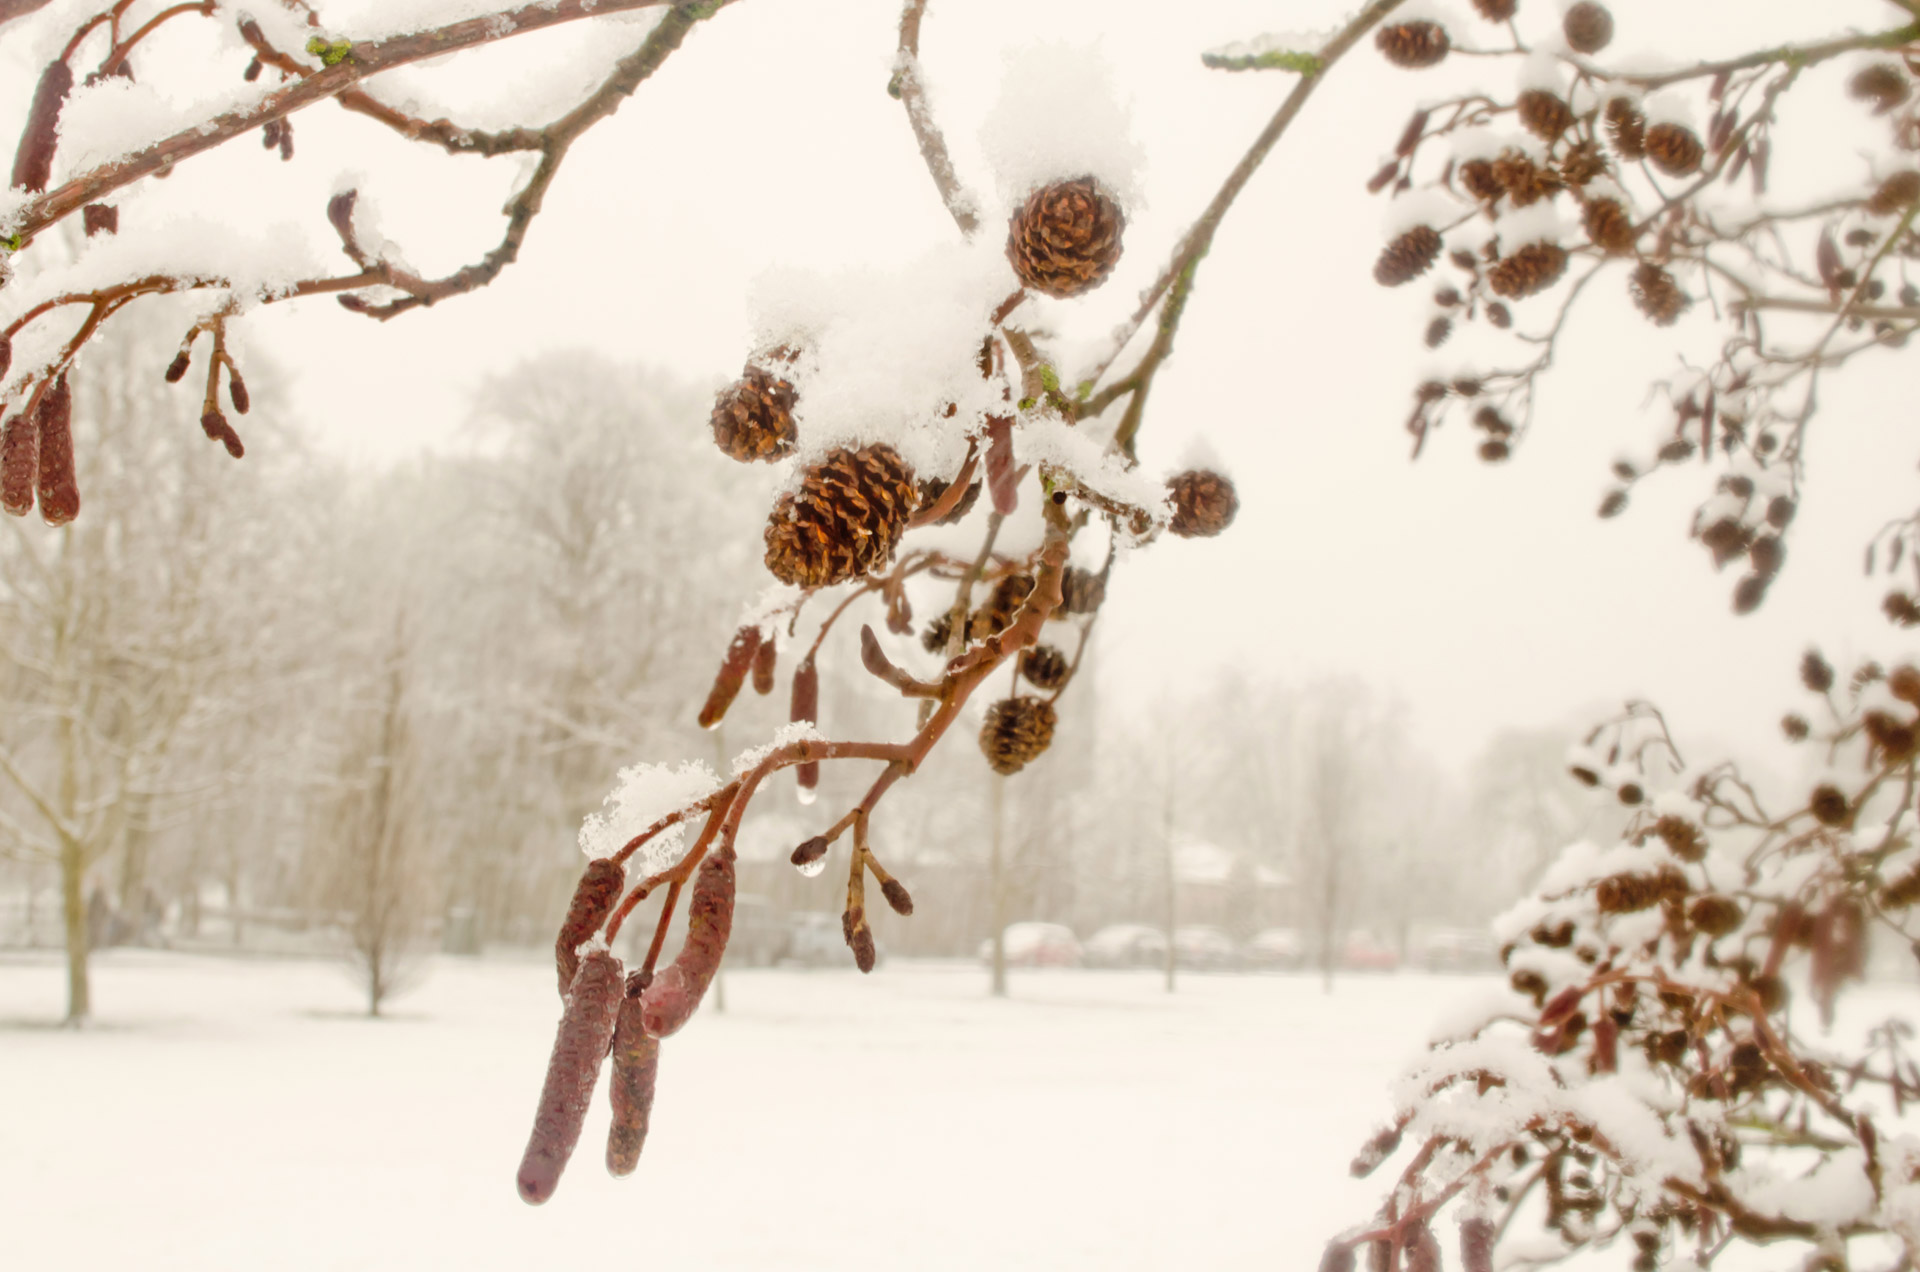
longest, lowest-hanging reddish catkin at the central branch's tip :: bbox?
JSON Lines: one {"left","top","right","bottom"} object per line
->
{"left": 516, "top": 949, "right": 624, "bottom": 1207}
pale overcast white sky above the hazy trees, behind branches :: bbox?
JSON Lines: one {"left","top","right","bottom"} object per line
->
{"left": 0, "top": 0, "right": 1916, "bottom": 767}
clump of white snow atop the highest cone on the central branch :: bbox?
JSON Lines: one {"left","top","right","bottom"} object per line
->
{"left": 979, "top": 44, "right": 1146, "bottom": 206}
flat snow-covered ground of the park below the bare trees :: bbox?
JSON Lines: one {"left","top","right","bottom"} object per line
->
{"left": 0, "top": 953, "right": 1912, "bottom": 1272}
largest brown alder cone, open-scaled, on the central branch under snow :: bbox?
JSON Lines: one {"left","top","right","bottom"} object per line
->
{"left": 766, "top": 444, "right": 918, "bottom": 588}
